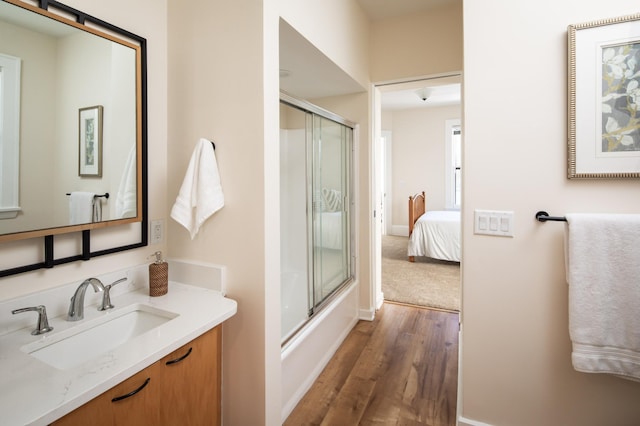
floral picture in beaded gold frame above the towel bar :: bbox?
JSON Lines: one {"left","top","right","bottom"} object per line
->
{"left": 567, "top": 14, "right": 640, "bottom": 179}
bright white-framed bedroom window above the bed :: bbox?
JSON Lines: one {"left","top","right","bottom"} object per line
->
{"left": 445, "top": 119, "right": 462, "bottom": 210}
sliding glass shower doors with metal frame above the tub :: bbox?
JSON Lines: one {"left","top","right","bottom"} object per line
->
{"left": 280, "top": 96, "right": 353, "bottom": 344}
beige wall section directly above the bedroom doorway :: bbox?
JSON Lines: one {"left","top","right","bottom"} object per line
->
{"left": 370, "top": 0, "right": 462, "bottom": 82}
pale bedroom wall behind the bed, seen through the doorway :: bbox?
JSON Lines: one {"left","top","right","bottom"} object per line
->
{"left": 387, "top": 105, "right": 461, "bottom": 227}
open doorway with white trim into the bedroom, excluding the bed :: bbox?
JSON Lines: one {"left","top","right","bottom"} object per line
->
{"left": 372, "top": 73, "right": 462, "bottom": 311}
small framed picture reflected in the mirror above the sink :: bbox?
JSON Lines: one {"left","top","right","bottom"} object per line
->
{"left": 78, "top": 105, "right": 103, "bottom": 177}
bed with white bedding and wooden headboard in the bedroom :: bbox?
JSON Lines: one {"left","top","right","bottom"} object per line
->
{"left": 407, "top": 191, "right": 460, "bottom": 262}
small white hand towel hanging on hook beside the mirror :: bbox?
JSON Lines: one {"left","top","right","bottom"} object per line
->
{"left": 171, "top": 139, "right": 224, "bottom": 240}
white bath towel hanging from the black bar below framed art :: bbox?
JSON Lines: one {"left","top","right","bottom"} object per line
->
{"left": 565, "top": 214, "right": 640, "bottom": 380}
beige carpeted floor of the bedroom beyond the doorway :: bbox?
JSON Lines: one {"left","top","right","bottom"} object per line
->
{"left": 382, "top": 235, "right": 460, "bottom": 311}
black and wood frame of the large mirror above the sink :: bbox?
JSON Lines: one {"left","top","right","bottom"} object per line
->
{"left": 0, "top": 0, "right": 148, "bottom": 277}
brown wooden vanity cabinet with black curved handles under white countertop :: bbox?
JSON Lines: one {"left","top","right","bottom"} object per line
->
{"left": 53, "top": 326, "right": 222, "bottom": 426}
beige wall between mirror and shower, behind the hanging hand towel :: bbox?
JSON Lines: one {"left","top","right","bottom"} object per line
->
{"left": 166, "top": 1, "right": 268, "bottom": 424}
